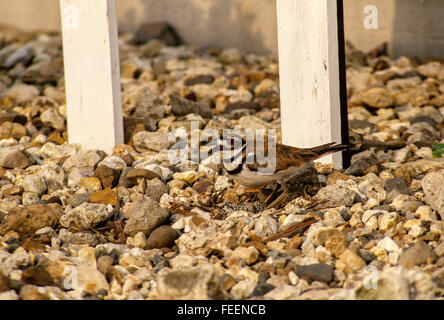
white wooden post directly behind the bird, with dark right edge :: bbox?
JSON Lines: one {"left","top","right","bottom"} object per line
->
{"left": 276, "top": 0, "right": 342, "bottom": 168}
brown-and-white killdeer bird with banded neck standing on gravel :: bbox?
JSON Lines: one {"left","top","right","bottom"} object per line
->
{"left": 214, "top": 133, "right": 351, "bottom": 208}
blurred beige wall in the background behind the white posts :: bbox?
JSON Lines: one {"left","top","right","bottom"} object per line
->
{"left": 0, "top": 0, "right": 444, "bottom": 59}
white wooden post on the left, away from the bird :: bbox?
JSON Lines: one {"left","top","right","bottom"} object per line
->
{"left": 60, "top": 0, "right": 123, "bottom": 154}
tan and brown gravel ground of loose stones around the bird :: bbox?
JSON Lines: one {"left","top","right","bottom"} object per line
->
{"left": 0, "top": 25, "right": 444, "bottom": 300}
